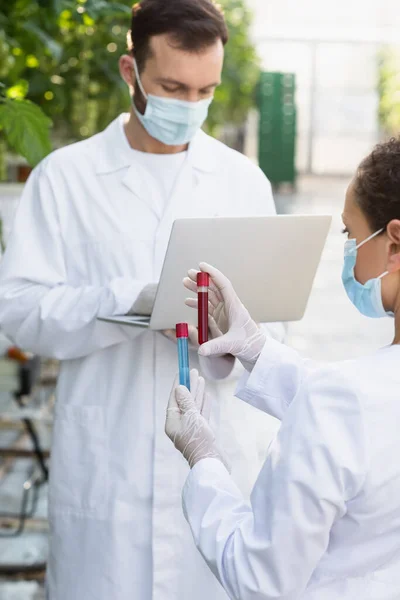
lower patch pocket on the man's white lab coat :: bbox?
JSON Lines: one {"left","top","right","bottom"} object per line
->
{"left": 49, "top": 406, "right": 109, "bottom": 517}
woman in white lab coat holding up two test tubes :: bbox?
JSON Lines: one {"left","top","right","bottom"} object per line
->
{"left": 166, "top": 139, "right": 400, "bottom": 600}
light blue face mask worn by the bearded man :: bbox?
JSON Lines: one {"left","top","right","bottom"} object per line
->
{"left": 132, "top": 60, "right": 213, "bottom": 146}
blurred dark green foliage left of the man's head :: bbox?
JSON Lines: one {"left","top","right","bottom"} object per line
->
{"left": 0, "top": 0, "right": 136, "bottom": 145}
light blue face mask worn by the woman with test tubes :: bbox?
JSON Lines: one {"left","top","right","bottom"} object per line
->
{"left": 342, "top": 229, "right": 393, "bottom": 318}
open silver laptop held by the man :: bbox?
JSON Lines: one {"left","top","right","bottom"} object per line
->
{"left": 101, "top": 215, "right": 331, "bottom": 330}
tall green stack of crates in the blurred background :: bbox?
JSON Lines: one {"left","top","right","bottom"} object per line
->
{"left": 258, "top": 73, "right": 297, "bottom": 185}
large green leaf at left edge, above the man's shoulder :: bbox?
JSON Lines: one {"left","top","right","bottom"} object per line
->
{"left": 0, "top": 99, "right": 51, "bottom": 166}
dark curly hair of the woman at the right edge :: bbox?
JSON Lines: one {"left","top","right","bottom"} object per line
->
{"left": 354, "top": 138, "right": 400, "bottom": 231}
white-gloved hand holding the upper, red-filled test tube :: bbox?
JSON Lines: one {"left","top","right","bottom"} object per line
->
{"left": 183, "top": 263, "right": 266, "bottom": 371}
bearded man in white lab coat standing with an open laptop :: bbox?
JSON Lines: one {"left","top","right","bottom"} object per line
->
{"left": 0, "top": 0, "right": 282, "bottom": 600}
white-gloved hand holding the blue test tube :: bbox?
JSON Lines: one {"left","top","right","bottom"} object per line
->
{"left": 165, "top": 369, "right": 229, "bottom": 470}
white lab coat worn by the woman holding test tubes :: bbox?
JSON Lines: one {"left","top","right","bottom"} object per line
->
{"left": 183, "top": 342, "right": 400, "bottom": 600}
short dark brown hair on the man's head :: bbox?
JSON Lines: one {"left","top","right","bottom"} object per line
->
{"left": 129, "top": 0, "right": 228, "bottom": 71}
